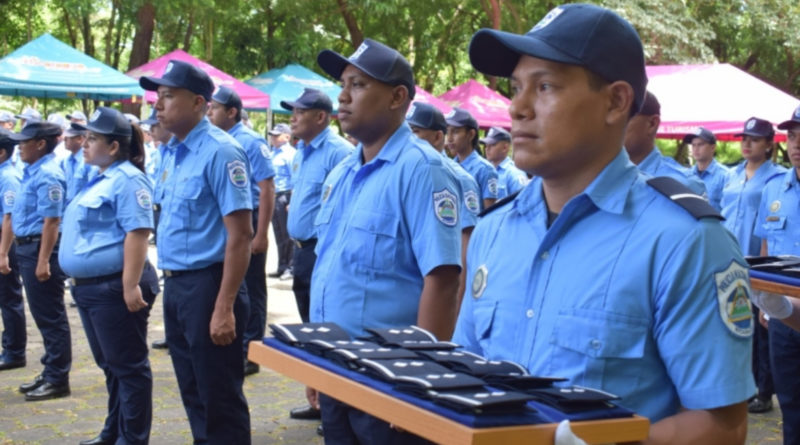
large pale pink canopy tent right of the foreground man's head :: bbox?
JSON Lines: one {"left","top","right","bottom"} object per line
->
{"left": 647, "top": 63, "right": 800, "bottom": 140}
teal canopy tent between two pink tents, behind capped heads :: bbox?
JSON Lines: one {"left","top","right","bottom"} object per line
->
{"left": 245, "top": 64, "right": 342, "bottom": 114}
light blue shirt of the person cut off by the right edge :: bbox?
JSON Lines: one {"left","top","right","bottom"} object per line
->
{"left": 755, "top": 168, "right": 800, "bottom": 255}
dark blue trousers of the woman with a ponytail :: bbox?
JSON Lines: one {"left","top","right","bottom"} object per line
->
{"left": 72, "top": 263, "right": 158, "bottom": 444}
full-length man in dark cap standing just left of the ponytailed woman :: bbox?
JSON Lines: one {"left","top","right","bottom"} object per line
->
{"left": 0, "top": 122, "right": 72, "bottom": 401}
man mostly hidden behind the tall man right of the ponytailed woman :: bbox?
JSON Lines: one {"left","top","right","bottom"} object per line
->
{"left": 208, "top": 86, "right": 275, "bottom": 375}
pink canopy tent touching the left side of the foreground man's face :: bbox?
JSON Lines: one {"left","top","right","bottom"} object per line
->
{"left": 439, "top": 79, "right": 511, "bottom": 128}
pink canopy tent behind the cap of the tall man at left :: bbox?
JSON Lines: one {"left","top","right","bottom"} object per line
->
{"left": 125, "top": 49, "right": 269, "bottom": 109}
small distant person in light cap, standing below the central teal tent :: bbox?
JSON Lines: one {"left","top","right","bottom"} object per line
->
{"left": 269, "top": 124, "right": 296, "bottom": 279}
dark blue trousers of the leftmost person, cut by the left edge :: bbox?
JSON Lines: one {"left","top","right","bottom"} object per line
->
{"left": 0, "top": 244, "right": 28, "bottom": 361}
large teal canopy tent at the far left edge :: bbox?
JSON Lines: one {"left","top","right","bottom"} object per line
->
{"left": 0, "top": 34, "right": 144, "bottom": 101}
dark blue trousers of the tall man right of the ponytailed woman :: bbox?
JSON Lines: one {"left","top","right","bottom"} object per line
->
{"left": 164, "top": 264, "right": 250, "bottom": 445}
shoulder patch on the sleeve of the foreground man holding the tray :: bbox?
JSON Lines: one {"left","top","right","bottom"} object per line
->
{"left": 714, "top": 261, "right": 753, "bottom": 338}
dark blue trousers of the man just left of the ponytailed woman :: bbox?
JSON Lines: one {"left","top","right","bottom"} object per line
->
{"left": 17, "top": 242, "right": 72, "bottom": 385}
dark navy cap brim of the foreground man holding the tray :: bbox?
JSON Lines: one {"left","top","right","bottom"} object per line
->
{"left": 469, "top": 28, "right": 583, "bottom": 77}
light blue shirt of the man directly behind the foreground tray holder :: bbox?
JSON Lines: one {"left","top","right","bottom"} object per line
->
{"left": 312, "top": 123, "right": 461, "bottom": 336}
